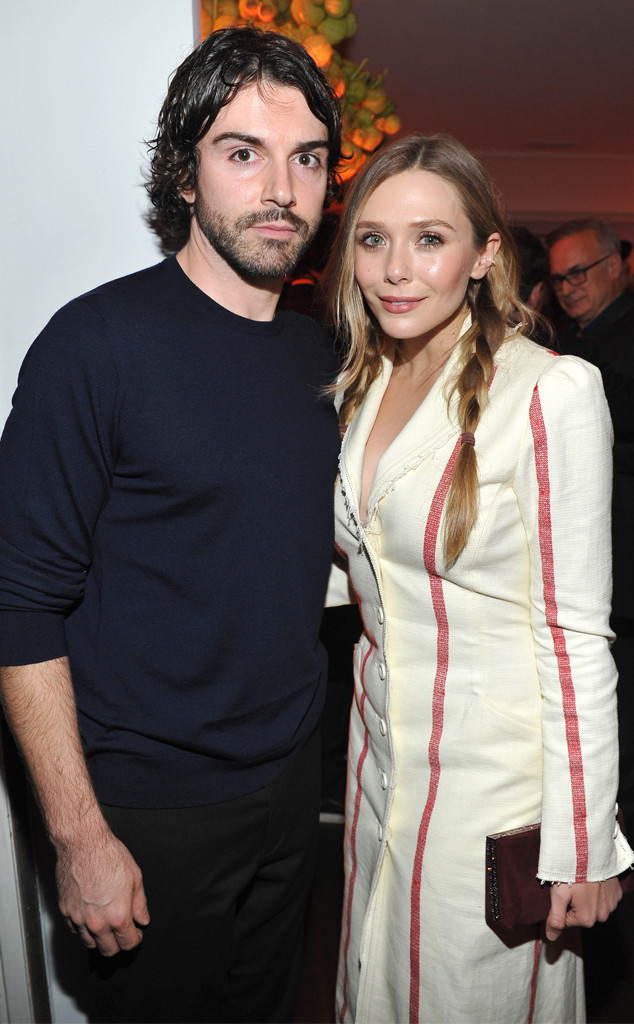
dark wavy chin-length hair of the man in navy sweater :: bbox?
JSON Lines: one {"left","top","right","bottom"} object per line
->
{"left": 145, "top": 27, "right": 341, "bottom": 252}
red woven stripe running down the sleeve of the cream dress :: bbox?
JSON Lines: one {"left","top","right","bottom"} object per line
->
{"left": 530, "top": 386, "right": 588, "bottom": 882}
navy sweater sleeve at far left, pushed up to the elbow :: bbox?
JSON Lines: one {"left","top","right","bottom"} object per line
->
{"left": 0, "top": 299, "right": 118, "bottom": 665}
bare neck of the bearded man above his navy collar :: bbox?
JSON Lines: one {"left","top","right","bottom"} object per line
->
{"left": 176, "top": 238, "right": 284, "bottom": 321}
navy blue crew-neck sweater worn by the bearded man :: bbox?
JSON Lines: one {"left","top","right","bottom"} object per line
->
{"left": 0, "top": 257, "right": 338, "bottom": 807}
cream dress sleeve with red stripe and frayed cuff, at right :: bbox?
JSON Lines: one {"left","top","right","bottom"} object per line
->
{"left": 516, "top": 356, "right": 634, "bottom": 882}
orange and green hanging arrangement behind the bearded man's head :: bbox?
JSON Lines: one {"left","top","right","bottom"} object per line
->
{"left": 201, "top": 0, "right": 400, "bottom": 181}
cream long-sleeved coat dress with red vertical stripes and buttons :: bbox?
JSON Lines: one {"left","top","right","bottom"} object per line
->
{"left": 336, "top": 336, "right": 633, "bottom": 1024}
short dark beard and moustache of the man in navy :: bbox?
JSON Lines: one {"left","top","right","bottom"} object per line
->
{"left": 194, "top": 196, "right": 319, "bottom": 280}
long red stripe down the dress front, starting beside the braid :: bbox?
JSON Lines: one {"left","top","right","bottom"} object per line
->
{"left": 410, "top": 439, "right": 461, "bottom": 1024}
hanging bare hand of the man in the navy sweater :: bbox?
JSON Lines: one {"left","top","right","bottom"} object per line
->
{"left": 56, "top": 830, "right": 150, "bottom": 956}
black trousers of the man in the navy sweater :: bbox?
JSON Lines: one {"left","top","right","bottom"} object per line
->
{"left": 90, "top": 731, "right": 320, "bottom": 1024}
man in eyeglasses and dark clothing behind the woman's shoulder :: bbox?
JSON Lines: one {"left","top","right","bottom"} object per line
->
{"left": 546, "top": 220, "right": 634, "bottom": 836}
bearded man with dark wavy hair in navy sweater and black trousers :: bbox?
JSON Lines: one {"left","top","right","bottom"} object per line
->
{"left": 0, "top": 28, "right": 340, "bottom": 1021}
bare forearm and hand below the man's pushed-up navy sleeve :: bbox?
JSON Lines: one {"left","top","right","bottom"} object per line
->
{"left": 0, "top": 657, "right": 150, "bottom": 956}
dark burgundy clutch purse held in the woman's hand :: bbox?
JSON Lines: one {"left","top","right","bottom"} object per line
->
{"left": 484, "top": 812, "right": 634, "bottom": 929}
